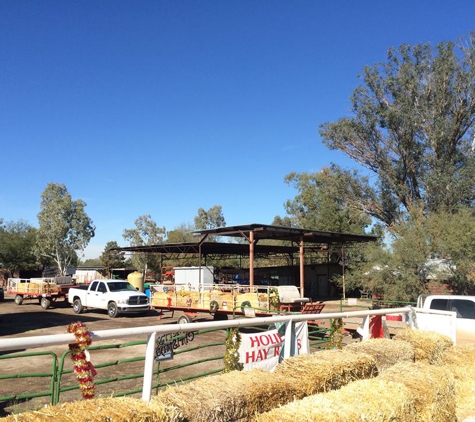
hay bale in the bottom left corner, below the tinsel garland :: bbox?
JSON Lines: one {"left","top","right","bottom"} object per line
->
{"left": 2, "top": 397, "right": 183, "bottom": 422}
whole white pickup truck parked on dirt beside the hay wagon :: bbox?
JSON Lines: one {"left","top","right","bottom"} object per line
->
{"left": 68, "top": 280, "right": 150, "bottom": 318}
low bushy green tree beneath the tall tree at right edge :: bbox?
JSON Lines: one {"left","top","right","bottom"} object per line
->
{"left": 346, "top": 207, "right": 475, "bottom": 301}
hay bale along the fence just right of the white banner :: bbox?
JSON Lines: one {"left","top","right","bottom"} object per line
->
{"left": 274, "top": 348, "right": 378, "bottom": 398}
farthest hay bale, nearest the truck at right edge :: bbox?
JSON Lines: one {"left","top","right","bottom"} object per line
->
{"left": 393, "top": 328, "right": 453, "bottom": 365}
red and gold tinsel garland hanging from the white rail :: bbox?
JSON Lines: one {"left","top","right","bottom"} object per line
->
{"left": 68, "top": 322, "right": 96, "bottom": 399}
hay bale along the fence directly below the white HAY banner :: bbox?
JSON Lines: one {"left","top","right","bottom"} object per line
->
{"left": 156, "top": 369, "right": 304, "bottom": 422}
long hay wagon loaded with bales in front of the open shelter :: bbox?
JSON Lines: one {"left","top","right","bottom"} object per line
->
{"left": 150, "top": 283, "right": 279, "bottom": 324}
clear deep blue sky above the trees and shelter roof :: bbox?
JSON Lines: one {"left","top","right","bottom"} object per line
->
{"left": 0, "top": 0, "right": 475, "bottom": 258}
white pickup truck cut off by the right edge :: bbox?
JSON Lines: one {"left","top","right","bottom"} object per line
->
{"left": 417, "top": 295, "right": 475, "bottom": 344}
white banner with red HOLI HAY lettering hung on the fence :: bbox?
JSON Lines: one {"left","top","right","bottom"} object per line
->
{"left": 239, "top": 321, "right": 310, "bottom": 371}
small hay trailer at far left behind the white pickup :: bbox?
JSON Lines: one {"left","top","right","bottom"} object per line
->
{"left": 7, "top": 277, "right": 73, "bottom": 309}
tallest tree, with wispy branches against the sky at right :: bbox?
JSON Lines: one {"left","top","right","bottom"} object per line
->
{"left": 320, "top": 34, "right": 475, "bottom": 226}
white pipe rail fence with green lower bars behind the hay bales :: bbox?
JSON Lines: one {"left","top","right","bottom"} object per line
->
{"left": 0, "top": 307, "right": 412, "bottom": 412}
